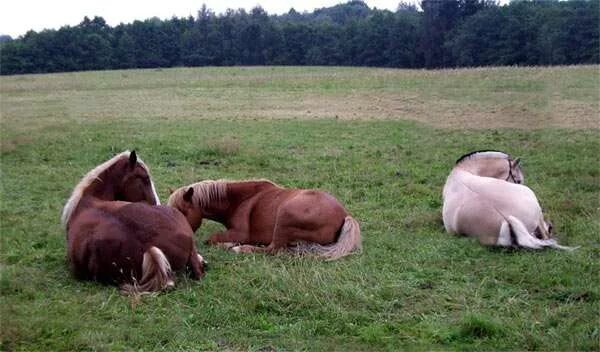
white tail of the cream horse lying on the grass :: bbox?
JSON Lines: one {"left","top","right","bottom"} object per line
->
{"left": 497, "top": 215, "right": 577, "bottom": 251}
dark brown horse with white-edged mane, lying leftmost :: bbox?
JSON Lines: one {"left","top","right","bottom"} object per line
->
{"left": 61, "top": 151, "right": 204, "bottom": 294}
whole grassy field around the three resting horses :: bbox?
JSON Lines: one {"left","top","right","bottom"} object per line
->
{"left": 0, "top": 66, "right": 600, "bottom": 351}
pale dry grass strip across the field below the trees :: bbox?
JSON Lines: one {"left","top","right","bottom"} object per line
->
{"left": 0, "top": 66, "right": 600, "bottom": 139}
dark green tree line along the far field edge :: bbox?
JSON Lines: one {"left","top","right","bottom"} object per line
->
{"left": 0, "top": 0, "right": 600, "bottom": 75}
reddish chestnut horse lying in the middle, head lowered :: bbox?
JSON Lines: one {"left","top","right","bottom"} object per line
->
{"left": 168, "top": 180, "right": 361, "bottom": 260}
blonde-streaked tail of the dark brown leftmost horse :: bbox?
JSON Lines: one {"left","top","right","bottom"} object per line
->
{"left": 121, "top": 247, "right": 175, "bottom": 294}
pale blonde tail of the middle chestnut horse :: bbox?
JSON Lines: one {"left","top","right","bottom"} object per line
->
{"left": 292, "top": 216, "right": 362, "bottom": 260}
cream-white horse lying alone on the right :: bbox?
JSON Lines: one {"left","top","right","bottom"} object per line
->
{"left": 442, "top": 150, "right": 573, "bottom": 250}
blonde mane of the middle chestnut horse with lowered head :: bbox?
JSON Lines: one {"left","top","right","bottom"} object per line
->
{"left": 168, "top": 179, "right": 279, "bottom": 208}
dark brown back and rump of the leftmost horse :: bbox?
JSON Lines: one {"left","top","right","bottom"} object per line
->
{"left": 67, "top": 202, "right": 194, "bottom": 283}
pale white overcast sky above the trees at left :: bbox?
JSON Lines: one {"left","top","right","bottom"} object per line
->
{"left": 0, "top": 0, "right": 420, "bottom": 38}
